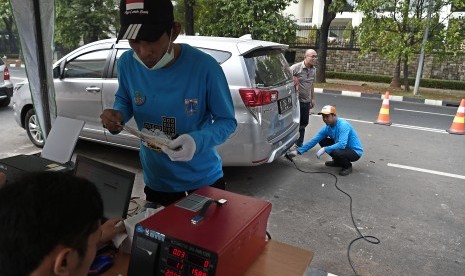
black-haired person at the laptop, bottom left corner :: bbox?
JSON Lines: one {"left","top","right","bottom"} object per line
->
{"left": 0, "top": 172, "right": 124, "bottom": 276}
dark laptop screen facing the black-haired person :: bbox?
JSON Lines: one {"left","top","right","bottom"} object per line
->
{"left": 74, "top": 155, "right": 135, "bottom": 219}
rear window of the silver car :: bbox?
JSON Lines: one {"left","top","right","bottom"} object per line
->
{"left": 244, "top": 49, "right": 292, "bottom": 87}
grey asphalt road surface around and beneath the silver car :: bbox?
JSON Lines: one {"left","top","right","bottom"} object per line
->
{"left": 0, "top": 72, "right": 465, "bottom": 275}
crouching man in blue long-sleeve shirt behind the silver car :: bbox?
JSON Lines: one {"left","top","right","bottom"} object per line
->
{"left": 290, "top": 105, "right": 363, "bottom": 176}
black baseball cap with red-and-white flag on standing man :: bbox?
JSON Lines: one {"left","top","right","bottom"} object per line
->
{"left": 116, "top": 0, "right": 174, "bottom": 42}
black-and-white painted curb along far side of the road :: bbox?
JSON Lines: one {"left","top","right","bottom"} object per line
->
{"left": 315, "top": 88, "right": 460, "bottom": 107}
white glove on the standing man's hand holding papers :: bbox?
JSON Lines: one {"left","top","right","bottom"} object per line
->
{"left": 161, "top": 134, "right": 197, "bottom": 161}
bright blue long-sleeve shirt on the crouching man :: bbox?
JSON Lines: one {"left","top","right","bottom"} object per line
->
{"left": 298, "top": 118, "right": 363, "bottom": 156}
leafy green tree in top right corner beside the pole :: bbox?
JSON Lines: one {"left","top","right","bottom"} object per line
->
{"left": 356, "top": 0, "right": 465, "bottom": 91}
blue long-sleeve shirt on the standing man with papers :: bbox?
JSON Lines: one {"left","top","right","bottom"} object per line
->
{"left": 113, "top": 44, "right": 237, "bottom": 192}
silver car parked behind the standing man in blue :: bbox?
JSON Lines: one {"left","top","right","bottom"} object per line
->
{"left": 13, "top": 36, "right": 300, "bottom": 166}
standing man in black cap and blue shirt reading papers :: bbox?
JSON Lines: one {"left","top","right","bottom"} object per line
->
{"left": 100, "top": 0, "right": 237, "bottom": 206}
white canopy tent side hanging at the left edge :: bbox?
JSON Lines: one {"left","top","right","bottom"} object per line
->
{"left": 10, "top": 0, "right": 56, "bottom": 139}
